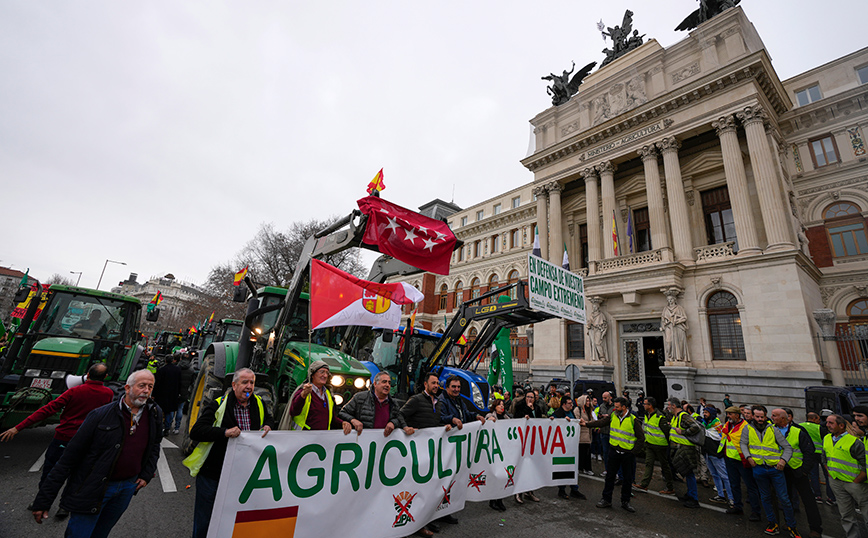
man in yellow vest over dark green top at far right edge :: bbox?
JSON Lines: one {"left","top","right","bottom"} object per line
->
{"left": 823, "top": 415, "right": 868, "bottom": 538}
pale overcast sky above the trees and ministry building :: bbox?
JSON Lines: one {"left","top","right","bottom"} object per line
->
{"left": 0, "top": 0, "right": 868, "bottom": 289}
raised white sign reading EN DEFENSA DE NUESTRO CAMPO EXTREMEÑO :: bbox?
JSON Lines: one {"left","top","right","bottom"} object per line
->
{"left": 527, "top": 254, "right": 586, "bottom": 323}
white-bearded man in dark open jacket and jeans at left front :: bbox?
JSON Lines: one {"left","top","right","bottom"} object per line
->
{"left": 33, "top": 370, "right": 163, "bottom": 537}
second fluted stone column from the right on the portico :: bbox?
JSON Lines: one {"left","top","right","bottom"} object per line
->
{"left": 711, "top": 114, "right": 762, "bottom": 256}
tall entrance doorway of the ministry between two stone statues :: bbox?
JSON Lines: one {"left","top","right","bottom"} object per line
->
{"left": 618, "top": 320, "right": 666, "bottom": 406}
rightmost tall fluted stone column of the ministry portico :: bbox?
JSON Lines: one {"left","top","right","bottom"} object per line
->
{"left": 736, "top": 105, "right": 796, "bottom": 251}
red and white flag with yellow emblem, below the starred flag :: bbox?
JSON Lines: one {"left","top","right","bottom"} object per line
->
{"left": 310, "top": 260, "right": 424, "bottom": 329}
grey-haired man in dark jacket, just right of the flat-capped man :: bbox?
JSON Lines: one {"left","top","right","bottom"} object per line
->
{"left": 338, "top": 371, "right": 416, "bottom": 437}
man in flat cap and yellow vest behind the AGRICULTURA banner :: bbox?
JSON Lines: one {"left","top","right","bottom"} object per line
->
{"left": 281, "top": 361, "right": 353, "bottom": 433}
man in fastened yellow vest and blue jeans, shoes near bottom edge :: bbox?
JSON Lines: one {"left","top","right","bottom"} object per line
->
{"left": 741, "top": 405, "right": 800, "bottom": 538}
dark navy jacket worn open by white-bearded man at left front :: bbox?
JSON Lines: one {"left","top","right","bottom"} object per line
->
{"left": 33, "top": 396, "right": 163, "bottom": 514}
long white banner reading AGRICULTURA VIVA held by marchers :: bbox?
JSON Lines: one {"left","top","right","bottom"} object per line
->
{"left": 208, "top": 419, "right": 579, "bottom": 538}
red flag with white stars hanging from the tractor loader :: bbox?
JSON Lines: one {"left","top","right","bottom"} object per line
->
{"left": 358, "top": 196, "right": 456, "bottom": 275}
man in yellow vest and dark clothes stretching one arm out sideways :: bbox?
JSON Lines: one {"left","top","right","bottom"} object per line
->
{"left": 579, "top": 397, "right": 645, "bottom": 513}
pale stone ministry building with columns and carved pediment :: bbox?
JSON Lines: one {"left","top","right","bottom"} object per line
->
{"left": 396, "top": 8, "right": 868, "bottom": 409}
